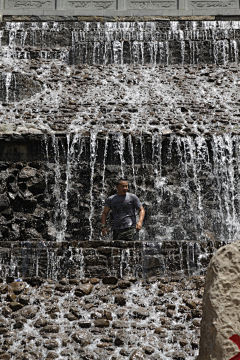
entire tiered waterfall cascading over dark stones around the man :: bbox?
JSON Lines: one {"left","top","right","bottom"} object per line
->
{"left": 0, "top": 21, "right": 240, "bottom": 360}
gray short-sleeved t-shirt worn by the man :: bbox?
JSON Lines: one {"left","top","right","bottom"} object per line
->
{"left": 105, "top": 192, "right": 142, "bottom": 229}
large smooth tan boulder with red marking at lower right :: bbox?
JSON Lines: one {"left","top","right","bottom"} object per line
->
{"left": 198, "top": 240, "right": 240, "bottom": 360}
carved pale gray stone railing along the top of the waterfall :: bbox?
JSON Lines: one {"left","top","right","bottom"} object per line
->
{"left": 0, "top": 0, "right": 240, "bottom": 20}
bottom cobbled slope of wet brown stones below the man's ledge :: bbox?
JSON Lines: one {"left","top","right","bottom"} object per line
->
{"left": 0, "top": 276, "right": 204, "bottom": 360}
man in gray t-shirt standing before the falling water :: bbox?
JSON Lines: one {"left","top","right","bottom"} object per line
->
{"left": 102, "top": 179, "right": 145, "bottom": 240}
